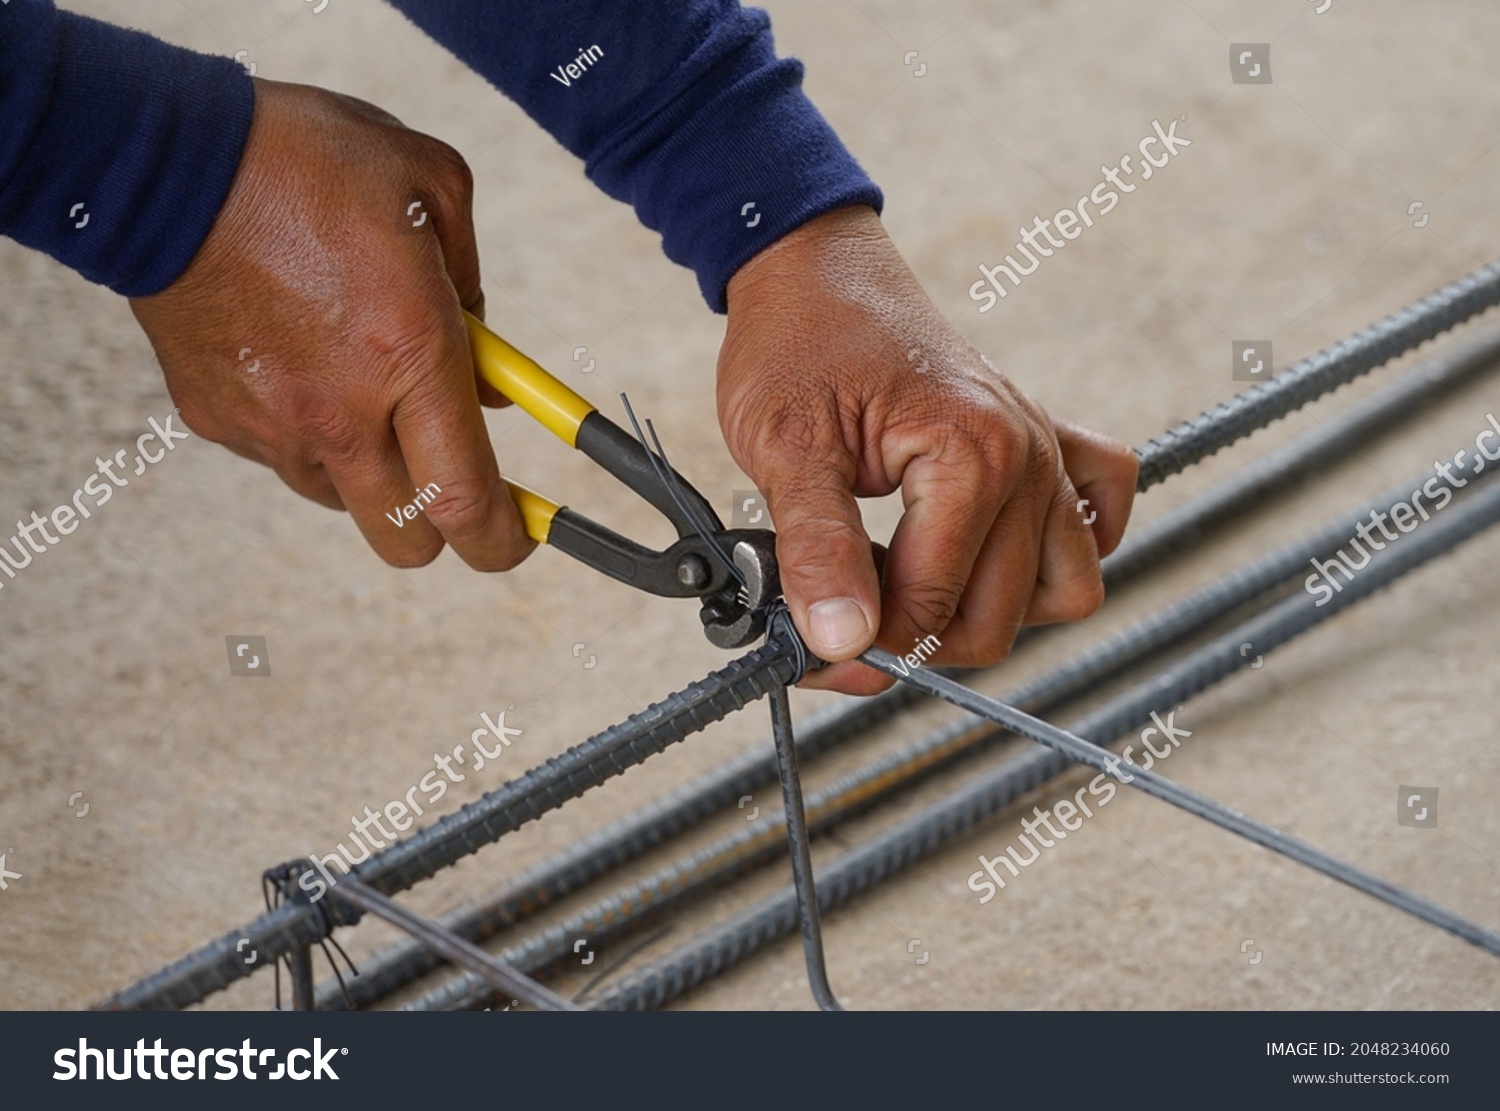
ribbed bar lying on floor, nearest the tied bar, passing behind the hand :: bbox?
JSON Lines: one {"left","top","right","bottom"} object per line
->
{"left": 307, "top": 328, "right": 1500, "bottom": 1009}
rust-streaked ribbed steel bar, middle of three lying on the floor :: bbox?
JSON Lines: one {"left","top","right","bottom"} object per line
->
{"left": 407, "top": 455, "right": 1497, "bottom": 1011}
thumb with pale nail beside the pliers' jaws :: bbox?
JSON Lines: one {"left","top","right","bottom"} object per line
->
{"left": 761, "top": 457, "right": 881, "bottom": 663}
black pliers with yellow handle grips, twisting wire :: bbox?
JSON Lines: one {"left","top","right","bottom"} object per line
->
{"left": 464, "top": 313, "right": 782, "bottom": 648}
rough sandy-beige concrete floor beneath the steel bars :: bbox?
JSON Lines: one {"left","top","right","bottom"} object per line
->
{"left": 0, "top": 0, "right": 1500, "bottom": 1009}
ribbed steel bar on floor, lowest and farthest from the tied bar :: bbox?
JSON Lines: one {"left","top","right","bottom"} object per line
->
{"left": 593, "top": 473, "right": 1500, "bottom": 1011}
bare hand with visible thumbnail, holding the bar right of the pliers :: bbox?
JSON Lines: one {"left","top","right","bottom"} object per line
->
{"left": 719, "top": 207, "right": 1136, "bottom": 694}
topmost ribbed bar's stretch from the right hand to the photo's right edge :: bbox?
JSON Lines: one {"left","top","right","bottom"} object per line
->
{"left": 1136, "top": 264, "right": 1500, "bottom": 490}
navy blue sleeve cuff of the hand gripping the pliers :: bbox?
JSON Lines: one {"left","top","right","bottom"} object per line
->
{"left": 0, "top": 0, "right": 255, "bottom": 297}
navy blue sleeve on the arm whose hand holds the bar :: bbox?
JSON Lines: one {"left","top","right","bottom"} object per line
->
{"left": 392, "top": 0, "right": 882, "bottom": 312}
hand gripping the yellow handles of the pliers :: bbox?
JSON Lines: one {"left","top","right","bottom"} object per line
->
{"left": 131, "top": 81, "right": 533, "bottom": 570}
